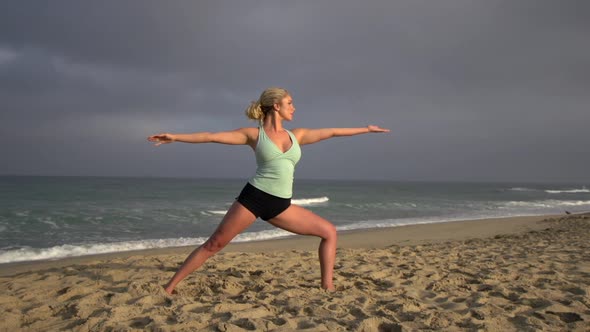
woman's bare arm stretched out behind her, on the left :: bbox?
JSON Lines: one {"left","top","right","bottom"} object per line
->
{"left": 148, "top": 128, "right": 256, "bottom": 146}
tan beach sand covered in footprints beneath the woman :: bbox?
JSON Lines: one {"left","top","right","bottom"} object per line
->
{"left": 0, "top": 214, "right": 590, "bottom": 331}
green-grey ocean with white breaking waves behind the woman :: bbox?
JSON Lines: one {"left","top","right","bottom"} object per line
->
{"left": 0, "top": 176, "right": 590, "bottom": 263}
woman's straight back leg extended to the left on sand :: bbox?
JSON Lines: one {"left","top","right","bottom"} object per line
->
{"left": 164, "top": 202, "right": 256, "bottom": 294}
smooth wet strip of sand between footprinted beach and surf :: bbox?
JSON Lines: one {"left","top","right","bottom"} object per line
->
{"left": 0, "top": 215, "right": 561, "bottom": 277}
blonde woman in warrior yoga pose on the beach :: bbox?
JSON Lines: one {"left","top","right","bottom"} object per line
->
{"left": 148, "top": 88, "right": 389, "bottom": 294}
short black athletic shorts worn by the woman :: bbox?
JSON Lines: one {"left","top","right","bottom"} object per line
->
{"left": 236, "top": 182, "right": 291, "bottom": 221}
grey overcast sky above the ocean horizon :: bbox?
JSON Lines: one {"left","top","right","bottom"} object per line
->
{"left": 0, "top": 0, "right": 590, "bottom": 183}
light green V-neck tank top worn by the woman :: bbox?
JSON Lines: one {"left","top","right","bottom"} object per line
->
{"left": 249, "top": 126, "right": 301, "bottom": 198}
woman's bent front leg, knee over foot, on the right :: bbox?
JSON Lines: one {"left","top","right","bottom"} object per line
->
{"left": 268, "top": 205, "right": 337, "bottom": 290}
